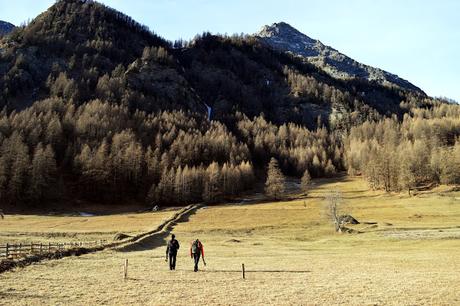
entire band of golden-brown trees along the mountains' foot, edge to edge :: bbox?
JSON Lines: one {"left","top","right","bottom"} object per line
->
{"left": 0, "top": 97, "right": 460, "bottom": 205}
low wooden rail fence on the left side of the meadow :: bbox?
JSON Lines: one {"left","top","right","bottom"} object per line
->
{"left": 0, "top": 240, "right": 106, "bottom": 258}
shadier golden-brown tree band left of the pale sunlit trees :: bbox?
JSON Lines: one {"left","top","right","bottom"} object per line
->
{"left": 0, "top": 92, "right": 352, "bottom": 204}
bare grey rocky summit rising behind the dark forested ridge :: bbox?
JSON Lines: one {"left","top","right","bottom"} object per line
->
{"left": 255, "top": 22, "right": 422, "bottom": 93}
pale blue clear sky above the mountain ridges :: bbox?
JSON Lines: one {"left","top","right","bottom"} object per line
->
{"left": 0, "top": 0, "right": 460, "bottom": 102}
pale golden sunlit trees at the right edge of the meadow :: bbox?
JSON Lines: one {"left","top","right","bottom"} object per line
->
{"left": 345, "top": 103, "right": 460, "bottom": 192}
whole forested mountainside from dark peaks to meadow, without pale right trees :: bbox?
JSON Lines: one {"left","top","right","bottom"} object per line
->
{"left": 0, "top": 0, "right": 459, "bottom": 209}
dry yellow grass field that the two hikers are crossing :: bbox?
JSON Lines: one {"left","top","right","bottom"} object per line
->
{"left": 0, "top": 177, "right": 460, "bottom": 305}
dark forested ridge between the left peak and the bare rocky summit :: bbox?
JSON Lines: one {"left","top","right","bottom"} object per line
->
{"left": 177, "top": 33, "right": 432, "bottom": 128}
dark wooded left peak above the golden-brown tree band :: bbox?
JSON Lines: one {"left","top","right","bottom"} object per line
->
{"left": 0, "top": 0, "right": 205, "bottom": 112}
